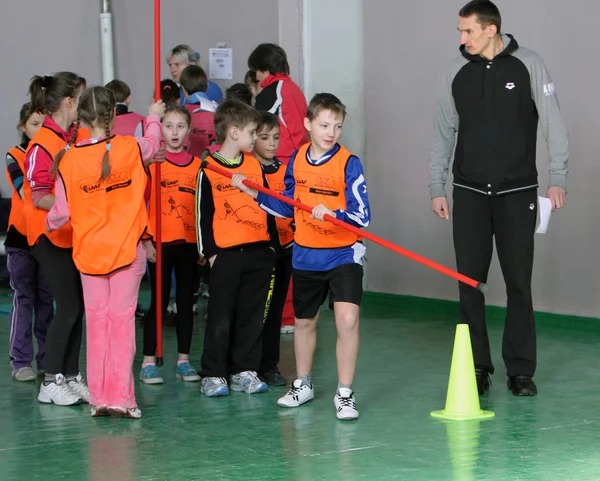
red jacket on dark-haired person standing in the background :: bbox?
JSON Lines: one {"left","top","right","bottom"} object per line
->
{"left": 255, "top": 74, "right": 308, "bottom": 164}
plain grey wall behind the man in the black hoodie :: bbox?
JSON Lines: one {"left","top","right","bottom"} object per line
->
{"left": 364, "top": 0, "right": 600, "bottom": 317}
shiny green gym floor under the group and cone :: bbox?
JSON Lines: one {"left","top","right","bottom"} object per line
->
{"left": 0, "top": 286, "right": 600, "bottom": 481}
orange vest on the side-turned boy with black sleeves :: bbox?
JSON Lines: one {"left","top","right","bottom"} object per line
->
{"left": 203, "top": 153, "right": 270, "bottom": 249}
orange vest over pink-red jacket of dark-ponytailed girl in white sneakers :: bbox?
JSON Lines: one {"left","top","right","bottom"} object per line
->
{"left": 23, "top": 127, "right": 90, "bottom": 248}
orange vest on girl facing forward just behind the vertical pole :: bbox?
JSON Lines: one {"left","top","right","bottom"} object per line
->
{"left": 148, "top": 152, "right": 202, "bottom": 244}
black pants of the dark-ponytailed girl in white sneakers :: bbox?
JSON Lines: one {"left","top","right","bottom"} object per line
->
{"left": 32, "top": 236, "right": 83, "bottom": 376}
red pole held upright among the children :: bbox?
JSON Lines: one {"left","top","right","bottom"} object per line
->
{"left": 154, "top": 0, "right": 163, "bottom": 366}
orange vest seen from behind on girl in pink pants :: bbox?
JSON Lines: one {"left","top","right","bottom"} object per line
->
{"left": 59, "top": 135, "right": 148, "bottom": 275}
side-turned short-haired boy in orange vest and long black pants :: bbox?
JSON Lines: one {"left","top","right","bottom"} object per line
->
{"left": 196, "top": 100, "right": 279, "bottom": 397}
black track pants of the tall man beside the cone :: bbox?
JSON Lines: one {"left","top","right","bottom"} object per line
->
{"left": 453, "top": 188, "right": 537, "bottom": 376}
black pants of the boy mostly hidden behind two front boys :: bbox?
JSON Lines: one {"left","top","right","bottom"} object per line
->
{"left": 260, "top": 248, "right": 292, "bottom": 372}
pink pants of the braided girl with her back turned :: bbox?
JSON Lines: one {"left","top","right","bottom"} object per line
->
{"left": 81, "top": 244, "right": 146, "bottom": 409}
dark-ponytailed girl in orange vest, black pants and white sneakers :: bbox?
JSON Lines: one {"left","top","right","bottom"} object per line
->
{"left": 23, "top": 72, "right": 89, "bottom": 406}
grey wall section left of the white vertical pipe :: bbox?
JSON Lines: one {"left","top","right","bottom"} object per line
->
{"left": 0, "top": 0, "right": 102, "bottom": 197}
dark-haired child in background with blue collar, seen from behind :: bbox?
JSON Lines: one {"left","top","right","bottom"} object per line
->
{"left": 179, "top": 65, "right": 218, "bottom": 157}
